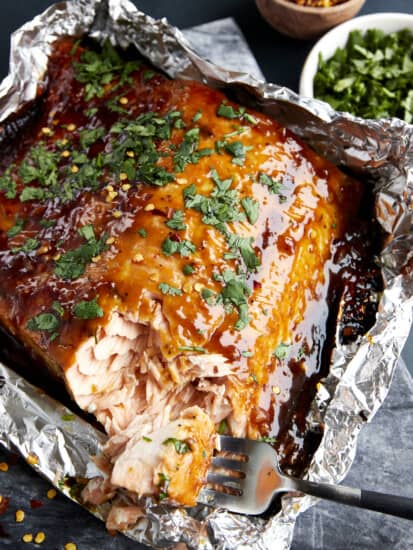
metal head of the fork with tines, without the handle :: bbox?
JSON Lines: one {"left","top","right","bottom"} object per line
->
{"left": 198, "top": 436, "right": 294, "bottom": 515}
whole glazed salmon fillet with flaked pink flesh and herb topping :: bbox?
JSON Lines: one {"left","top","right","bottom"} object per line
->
{"left": 0, "top": 40, "right": 361, "bottom": 526}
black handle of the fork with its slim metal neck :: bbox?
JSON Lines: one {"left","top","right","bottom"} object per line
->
{"left": 294, "top": 479, "right": 413, "bottom": 519}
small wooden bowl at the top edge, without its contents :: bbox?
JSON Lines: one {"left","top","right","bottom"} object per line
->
{"left": 256, "top": 0, "right": 365, "bottom": 39}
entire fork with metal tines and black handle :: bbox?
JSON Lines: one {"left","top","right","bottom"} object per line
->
{"left": 198, "top": 435, "right": 413, "bottom": 519}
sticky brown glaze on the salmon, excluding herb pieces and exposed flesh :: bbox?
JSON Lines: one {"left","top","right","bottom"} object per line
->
{"left": 0, "top": 40, "right": 381, "bottom": 484}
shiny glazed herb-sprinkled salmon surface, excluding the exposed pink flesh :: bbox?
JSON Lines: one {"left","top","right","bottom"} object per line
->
{"left": 0, "top": 40, "right": 381, "bottom": 474}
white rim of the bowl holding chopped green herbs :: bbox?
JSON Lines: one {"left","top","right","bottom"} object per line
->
{"left": 298, "top": 12, "right": 413, "bottom": 98}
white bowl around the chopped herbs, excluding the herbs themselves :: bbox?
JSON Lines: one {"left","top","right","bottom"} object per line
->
{"left": 299, "top": 13, "right": 413, "bottom": 97}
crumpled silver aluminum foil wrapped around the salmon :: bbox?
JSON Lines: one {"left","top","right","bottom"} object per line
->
{"left": 0, "top": 0, "right": 413, "bottom": 550}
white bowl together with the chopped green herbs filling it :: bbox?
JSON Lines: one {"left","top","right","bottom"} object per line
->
{"left": 299, "top": 13, "right": 413, "bottom": 123}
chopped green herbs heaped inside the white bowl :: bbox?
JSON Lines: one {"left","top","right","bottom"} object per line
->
{"left": 314, "top": 29, "right": 413, "bottom": 123}
